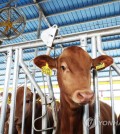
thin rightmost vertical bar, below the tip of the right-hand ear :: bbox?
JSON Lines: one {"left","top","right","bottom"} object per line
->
{"left": 109, "top": 67, "right": 116, "bottom": 134}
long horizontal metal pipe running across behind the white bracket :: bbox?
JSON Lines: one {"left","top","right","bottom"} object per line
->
{"left": 0, "top": 26, "right": 120, "bottom": 52}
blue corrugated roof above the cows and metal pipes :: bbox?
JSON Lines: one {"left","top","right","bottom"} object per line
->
{"left": 0, "top": 0, "right": 120, "bottom": 84}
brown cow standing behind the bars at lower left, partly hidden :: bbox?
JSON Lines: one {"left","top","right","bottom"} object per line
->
{"left": 15, "top": 87, "right": 53, "bottom": 134}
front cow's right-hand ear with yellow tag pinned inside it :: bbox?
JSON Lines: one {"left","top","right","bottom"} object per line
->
{"left": 92, "top": 55, "right": 113, "bottom": 71}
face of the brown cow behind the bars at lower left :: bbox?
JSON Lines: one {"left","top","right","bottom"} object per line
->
{"left": 15, "top": 87, "right": 33, "bottom": 124}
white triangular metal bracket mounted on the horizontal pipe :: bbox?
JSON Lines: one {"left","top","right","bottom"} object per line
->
{"left": 41, "top": 25, "right": 58, "bottom": 47}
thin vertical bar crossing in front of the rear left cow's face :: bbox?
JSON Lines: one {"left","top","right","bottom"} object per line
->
{"left": 21, "top": 74, "right": 27, "bottom": 134}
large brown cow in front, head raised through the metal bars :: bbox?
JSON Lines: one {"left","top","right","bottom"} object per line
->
{"left": 34, "top": 46, "right": 116, "bottom": 134}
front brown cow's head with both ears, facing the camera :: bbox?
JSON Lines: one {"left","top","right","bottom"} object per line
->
{"left": 34, "top": 46, "right": 113, "bottom": 105}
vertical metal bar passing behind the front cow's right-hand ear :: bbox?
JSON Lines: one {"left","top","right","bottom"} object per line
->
{"left": 92, "top": 37, "right": 101, "bottom": 134}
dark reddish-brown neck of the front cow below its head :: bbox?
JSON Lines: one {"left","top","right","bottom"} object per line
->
{"left": 59, "top": 92, "right": 83, "bottom": 134}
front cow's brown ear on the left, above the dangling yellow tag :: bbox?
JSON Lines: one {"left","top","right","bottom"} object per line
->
{"left": 34, "top": 55, "right": 57, "bottom": 69}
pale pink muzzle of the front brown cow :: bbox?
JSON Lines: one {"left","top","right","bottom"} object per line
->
{"left": 72, "top": 90, "right": 94, "bottom": 105}
